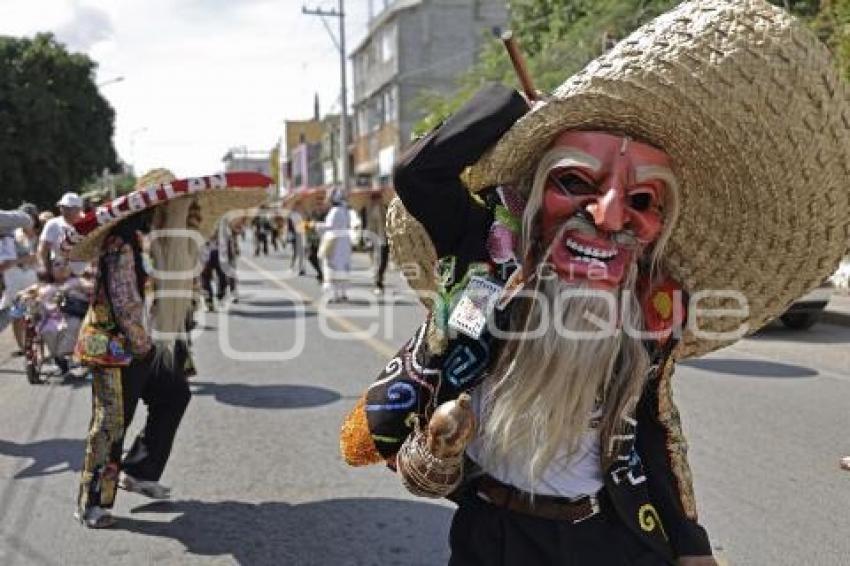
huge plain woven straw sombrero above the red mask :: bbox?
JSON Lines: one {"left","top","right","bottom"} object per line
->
{"left": 388, "top": 0, "right": 850, "bottom": 358}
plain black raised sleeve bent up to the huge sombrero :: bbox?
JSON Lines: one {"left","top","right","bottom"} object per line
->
{"left": 393, "top": 84, "right": 528, "bottom": 259}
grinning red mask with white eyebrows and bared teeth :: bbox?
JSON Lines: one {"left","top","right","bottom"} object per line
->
{"left": 542, "top": 131, "right": 674, "bottom": 289}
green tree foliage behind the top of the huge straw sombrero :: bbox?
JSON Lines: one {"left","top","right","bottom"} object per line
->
{"left": 416, "top": 0, "right": 850, "bottom": 133}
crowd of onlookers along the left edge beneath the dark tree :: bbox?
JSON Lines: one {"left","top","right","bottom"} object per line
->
{"left": 0, "top": 192, "right": 93, "bottom": 375}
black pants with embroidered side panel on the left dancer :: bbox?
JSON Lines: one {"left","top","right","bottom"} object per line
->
{"left": 78, "top": 348, "right": 191, "bottom": 509}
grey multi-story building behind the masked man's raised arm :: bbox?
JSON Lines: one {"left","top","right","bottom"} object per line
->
{"left": 351, "top": 0, "right": 507, "bottom": 188}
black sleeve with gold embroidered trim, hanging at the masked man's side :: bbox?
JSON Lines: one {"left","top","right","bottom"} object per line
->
{"left": 636, "top": 360, "right": 711, "bottom": 556}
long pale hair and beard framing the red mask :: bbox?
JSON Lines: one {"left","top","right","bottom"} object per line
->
{"left": 480, "top": 148, "right": 678, "bottom": 485}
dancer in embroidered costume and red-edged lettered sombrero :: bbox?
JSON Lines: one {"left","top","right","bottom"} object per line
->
{"left": 63, "top": 170, "right": 271, "bottom": 528}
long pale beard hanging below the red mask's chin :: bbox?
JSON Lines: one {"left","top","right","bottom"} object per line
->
{"left": 479, "top": 268, "right": 648, "bottom": 485}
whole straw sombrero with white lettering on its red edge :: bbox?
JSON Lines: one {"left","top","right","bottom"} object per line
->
{"left": 62, "top": 169, "right": 274, "bottom": 261}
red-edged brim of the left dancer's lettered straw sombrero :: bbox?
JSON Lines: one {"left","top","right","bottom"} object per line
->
{"left": 62, "top": 172, "right": 273, "bottom": 261}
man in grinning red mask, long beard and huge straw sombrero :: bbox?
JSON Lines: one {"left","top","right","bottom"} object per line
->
{"left": 342, "top": 0, "right": 850, "bottom": 566}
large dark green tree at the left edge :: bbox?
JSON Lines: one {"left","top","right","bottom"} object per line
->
{"left": 0, "top": 34, "right": 117, "bottom": 208}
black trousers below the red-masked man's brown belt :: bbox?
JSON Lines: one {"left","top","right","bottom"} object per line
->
{"left": 449, "top": 490, "right": 669, "bottom": 566}
